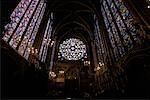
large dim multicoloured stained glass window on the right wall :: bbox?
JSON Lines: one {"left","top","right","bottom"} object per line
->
{"left": 101, "top": 0, "right": 139, "bottom": 59}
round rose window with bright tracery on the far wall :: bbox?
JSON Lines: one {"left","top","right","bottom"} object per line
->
{"left": 58, "top": 38, "right": 87, "bottom": 60}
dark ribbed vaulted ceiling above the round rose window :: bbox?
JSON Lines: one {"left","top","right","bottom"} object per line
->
{"left": 48, "top": 0, "right": 99, "bottom": 41}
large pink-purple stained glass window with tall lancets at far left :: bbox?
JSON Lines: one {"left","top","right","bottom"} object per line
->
{"left": 3, "top": 0, "right": 46, "bottom": 59}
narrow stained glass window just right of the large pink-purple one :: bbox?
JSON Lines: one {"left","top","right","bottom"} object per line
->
{"left": 39, "top": 13, "right": 53, "bottom": 62}
